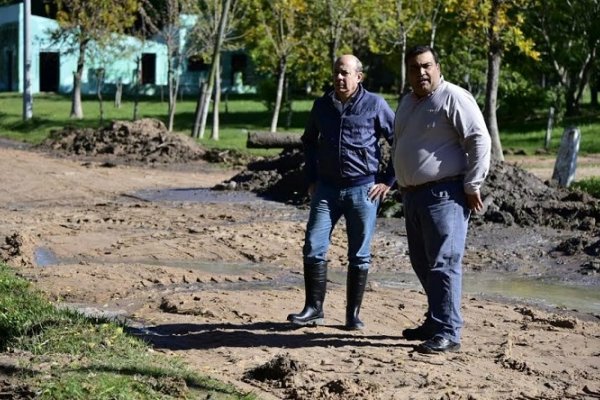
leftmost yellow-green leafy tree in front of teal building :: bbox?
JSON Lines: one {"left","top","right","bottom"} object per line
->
{"left": 52, "top": 0, "right": 139, "bottom": 119}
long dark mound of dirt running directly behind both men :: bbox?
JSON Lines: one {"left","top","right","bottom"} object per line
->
{"left": 216, "top": 150, "right": 600, "bottom": 245}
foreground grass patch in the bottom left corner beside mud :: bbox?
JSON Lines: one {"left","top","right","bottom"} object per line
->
{"left": 0, "top": 263, "right": 256, "bottom": 400}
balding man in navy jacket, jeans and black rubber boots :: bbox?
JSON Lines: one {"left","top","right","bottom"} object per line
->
{"left": 287, "top": 55, "right": 395, "bottom": 330}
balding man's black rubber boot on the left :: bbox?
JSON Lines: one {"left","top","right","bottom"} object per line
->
{"left": 287, "top": 262, "right": 327, "bottom": 325}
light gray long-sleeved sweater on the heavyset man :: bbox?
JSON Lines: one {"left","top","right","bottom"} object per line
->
{"left": 392, "top": 78, "right": 491, "bottom": 194}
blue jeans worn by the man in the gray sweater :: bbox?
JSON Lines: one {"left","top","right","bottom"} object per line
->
{"left": 403, "top": 181, "right": 470, "bottom": 343}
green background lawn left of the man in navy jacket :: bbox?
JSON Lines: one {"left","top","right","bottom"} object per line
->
{"left": 0, "top": 93, "right": 312, "bottom": 155}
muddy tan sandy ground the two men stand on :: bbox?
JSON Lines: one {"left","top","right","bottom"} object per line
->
{"left": 0, "top": 148, "right": 600, "bottom": 399}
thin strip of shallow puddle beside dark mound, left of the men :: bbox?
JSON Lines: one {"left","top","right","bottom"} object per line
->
{"left": 127, "top": 188, "right": 276, "bottom": 203}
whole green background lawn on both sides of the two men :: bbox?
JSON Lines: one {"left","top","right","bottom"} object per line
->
{"left": 0, "top": 93, "right": 600, "bottom": 155}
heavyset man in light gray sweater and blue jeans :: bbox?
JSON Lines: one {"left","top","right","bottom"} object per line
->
{"left": 392, "top": 46, "right": 491, "bottom": 353}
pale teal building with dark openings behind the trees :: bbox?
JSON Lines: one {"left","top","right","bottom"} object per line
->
{"left": 0, "top": 0, "right": 252, "bottom": 95}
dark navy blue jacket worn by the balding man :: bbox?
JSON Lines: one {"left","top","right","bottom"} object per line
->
{"left": 302, "top": 85, "right": 395, "bottom": 187}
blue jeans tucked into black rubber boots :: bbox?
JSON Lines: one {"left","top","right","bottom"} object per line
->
{"left": 302, "top": 182, "right": 379, "bottom": 270}
